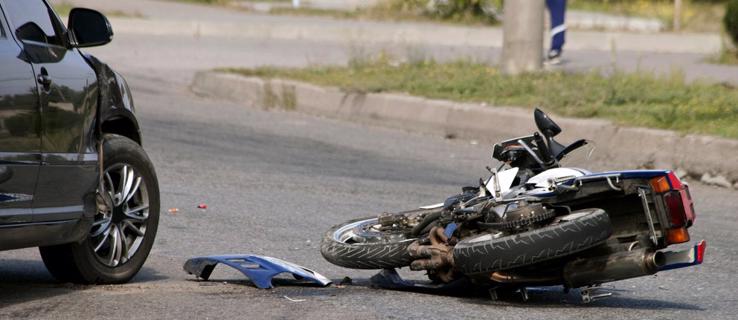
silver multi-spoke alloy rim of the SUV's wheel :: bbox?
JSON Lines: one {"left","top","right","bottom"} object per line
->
{"left": 89, "top": 163, "right": 149, "bottom": 267}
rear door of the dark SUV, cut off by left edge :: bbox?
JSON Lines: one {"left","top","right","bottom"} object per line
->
{"left": 0, "top": 4, "right": 41, "bottom": 225}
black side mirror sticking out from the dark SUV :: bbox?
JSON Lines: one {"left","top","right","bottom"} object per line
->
{"left": 67, "top": 8, "right": 113, "bottom": 48}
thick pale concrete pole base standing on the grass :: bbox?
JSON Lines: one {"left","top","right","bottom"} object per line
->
{"left": 500, "top": 0, "right": 546, "bottom": 74}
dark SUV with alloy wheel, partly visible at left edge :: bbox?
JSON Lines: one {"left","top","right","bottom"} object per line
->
{"left": 0, "top": 0, "right": 159, "bottom": 283}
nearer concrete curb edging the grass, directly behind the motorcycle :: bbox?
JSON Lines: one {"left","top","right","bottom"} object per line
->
{"left": 192, "top": 71, "right": 738, "bottom": 185}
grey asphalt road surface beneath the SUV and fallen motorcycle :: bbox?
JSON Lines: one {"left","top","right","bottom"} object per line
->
{"left": 0, "top": 1, "right": 738, "bottom": 320}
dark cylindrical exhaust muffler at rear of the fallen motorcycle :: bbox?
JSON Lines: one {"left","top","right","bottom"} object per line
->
{"left": 564, "top": 249, "right": 666, "bottom": 288}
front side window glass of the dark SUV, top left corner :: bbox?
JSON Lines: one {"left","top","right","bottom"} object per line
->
{"left": 4, "top": 0, "right": 61, "bottom": 45}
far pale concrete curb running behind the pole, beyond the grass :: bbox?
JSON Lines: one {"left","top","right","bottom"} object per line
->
{"left": 111, "top": 17, "right": 722, "bottom": 55}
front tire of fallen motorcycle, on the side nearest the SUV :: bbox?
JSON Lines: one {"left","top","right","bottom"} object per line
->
{"left": 320, "top": 218, "right": 416, "bottom": 269}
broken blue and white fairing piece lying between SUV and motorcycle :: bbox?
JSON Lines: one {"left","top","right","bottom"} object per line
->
{"left": 184, "top": 254, "right": 331, "bottom": 289}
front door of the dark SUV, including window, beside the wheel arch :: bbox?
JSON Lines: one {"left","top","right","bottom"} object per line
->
{"left": 2, "top": 0, "right": 98, "bottom": 221}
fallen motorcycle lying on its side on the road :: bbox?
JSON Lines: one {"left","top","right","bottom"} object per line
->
{"left": 321, "top": 109, "right": 706, "bottom": 302}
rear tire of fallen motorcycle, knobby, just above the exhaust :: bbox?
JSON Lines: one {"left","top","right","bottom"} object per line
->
{"left": 453, "top": 209, "right": 612, "bottom": 274}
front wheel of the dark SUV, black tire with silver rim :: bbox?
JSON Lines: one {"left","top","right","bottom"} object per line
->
{"left": 39, "top": 134, "right": 159, "bottom": 284}
